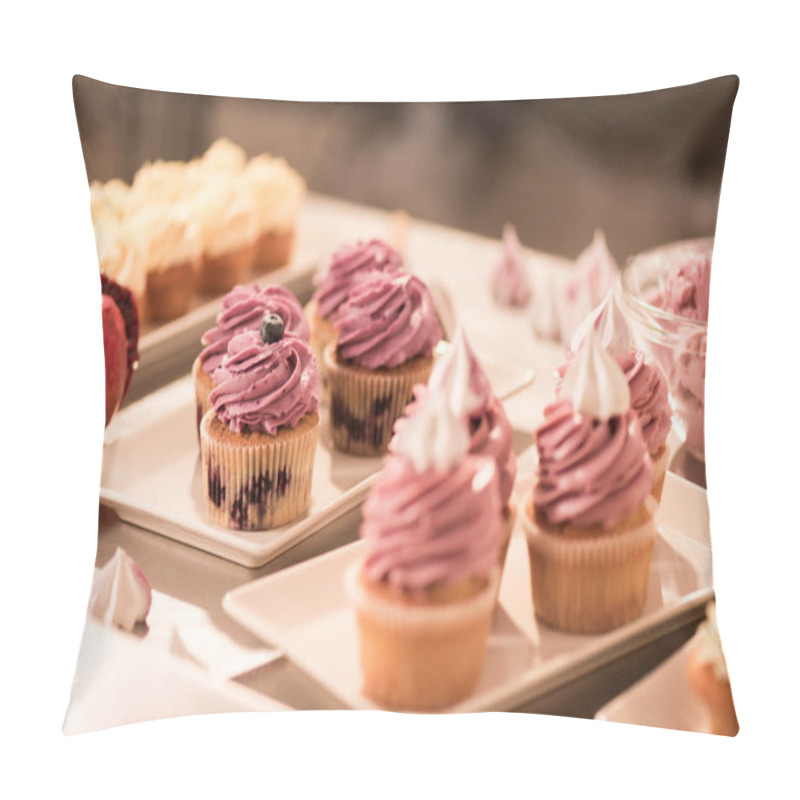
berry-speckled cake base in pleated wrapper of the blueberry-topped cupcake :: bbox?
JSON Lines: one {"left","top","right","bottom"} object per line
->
{"left": 200, "top": 410, "right": 319, "bottom": 530}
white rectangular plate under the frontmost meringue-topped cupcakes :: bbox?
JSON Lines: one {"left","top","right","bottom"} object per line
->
{"left": 223, "top": 462, "right": 713, "bottom": 712}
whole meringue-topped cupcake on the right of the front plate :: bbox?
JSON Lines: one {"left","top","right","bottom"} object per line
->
{"left": 520, "top": 328, "right": 656, "bottom": 634}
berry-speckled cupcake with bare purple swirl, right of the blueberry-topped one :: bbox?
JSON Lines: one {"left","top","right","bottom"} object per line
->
{"left": 322, "top": 271, "right": 442, "bottom": 456}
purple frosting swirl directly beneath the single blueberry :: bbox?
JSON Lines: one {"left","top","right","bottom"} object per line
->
{"left": 209, "top": 331, "right": 319, "bottom": 436}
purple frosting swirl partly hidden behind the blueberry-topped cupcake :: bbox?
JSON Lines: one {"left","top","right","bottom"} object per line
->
{"left": 200, "top": 286, "right": 309, "bottom": 372}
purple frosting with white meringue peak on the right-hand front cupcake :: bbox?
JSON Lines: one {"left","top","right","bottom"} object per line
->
{"left": 533, "top": 328, "right": 653, "bottom": 530}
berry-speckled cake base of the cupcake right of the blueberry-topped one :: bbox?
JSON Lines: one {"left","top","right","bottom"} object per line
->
{"left": 323, "top": 343, "right": 433, "bottom": 457}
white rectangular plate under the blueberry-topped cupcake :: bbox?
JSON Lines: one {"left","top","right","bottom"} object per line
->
{"left": 100, "top": 356, "right": 533, "bottom": 568}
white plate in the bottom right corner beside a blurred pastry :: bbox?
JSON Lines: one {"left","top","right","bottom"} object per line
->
{"left": 595, "top": 640, "right": 709, "bottom": 733}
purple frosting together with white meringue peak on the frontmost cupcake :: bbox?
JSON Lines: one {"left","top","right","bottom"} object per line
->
{"left": 360, "top": 395, "right": 502, "bottom": 595}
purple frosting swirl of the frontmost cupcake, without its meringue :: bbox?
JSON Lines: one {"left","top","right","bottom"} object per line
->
{"left": 360, "top": 455, "right": 501, "bottom": 592}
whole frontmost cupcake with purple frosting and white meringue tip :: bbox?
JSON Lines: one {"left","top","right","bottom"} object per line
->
{"left": 345, "top": 395, "right": 502, "bottom": 711}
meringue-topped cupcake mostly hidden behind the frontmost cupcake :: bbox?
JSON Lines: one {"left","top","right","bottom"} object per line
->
{"left": 389, "top": 328, "right": 517, "bottom": 569}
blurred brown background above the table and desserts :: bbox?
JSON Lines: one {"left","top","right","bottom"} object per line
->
{"left": 73, "top": 75, "right": 739, "bottom": 265}
